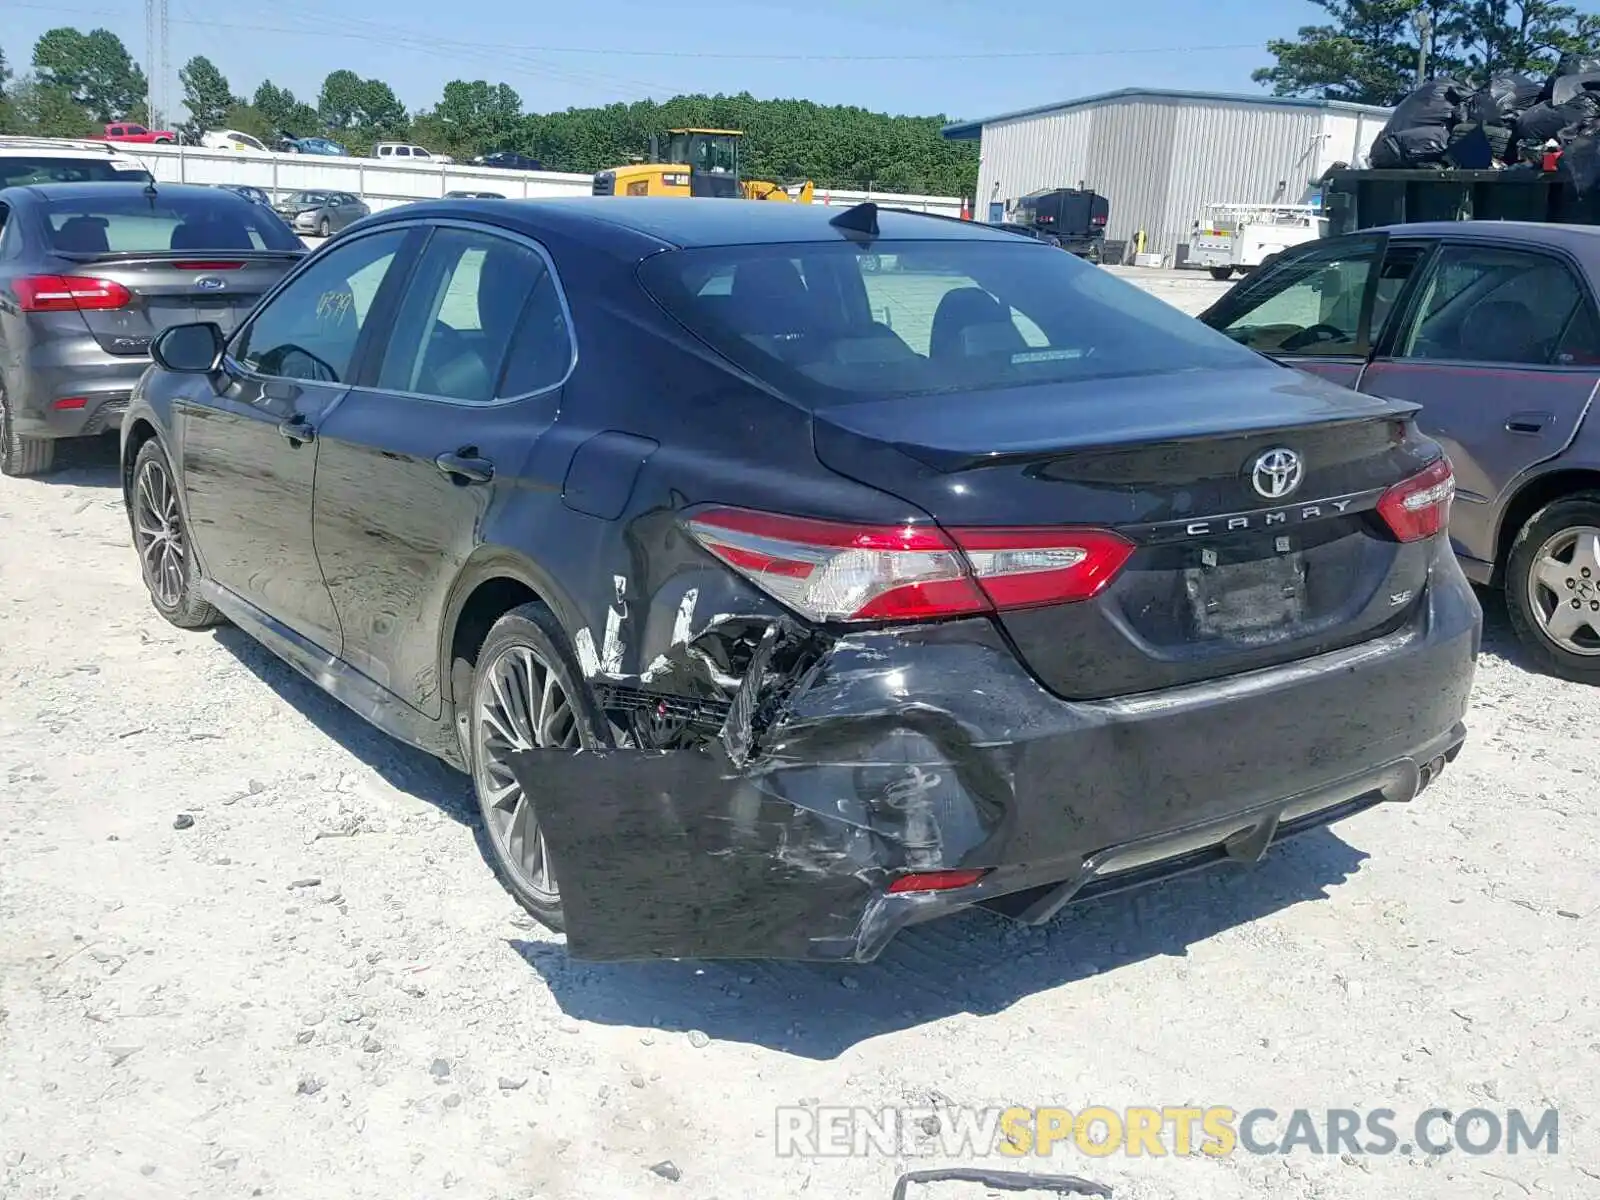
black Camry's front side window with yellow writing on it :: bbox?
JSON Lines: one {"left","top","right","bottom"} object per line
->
{"left": 232, "top": 229, "right": 406, "bottom": 384}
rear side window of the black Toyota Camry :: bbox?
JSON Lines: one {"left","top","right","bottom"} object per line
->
{"left": 378, "top": 229, "right": 571, "bottom": 403}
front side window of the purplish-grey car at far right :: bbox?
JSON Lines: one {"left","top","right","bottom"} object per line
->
{"left": 1219, "top": 240, "right": 1379, "bottom": 357}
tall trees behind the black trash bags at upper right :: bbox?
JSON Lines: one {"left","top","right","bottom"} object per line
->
{"left": 1253, "top": 0, "right": 1600, "bottom": 106}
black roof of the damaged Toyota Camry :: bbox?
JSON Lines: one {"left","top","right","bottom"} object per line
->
{"left": 371, "top": 195, "right": 1016, "bottom": 248}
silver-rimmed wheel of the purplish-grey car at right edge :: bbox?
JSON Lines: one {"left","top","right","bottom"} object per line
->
{"left": 1506, "top": 491, "right": 1600, "bottom": 683}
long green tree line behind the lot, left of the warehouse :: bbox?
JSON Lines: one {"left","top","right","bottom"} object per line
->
{"left": 0, "top": 29, "right": 978, "bottom": 195}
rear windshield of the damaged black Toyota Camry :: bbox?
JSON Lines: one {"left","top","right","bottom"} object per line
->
{"left": 640, "top": 238, "right": 1267, "bottom": 405}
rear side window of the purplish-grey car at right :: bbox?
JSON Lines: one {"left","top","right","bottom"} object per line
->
{"left": 1395, "top": 246, "right": 1587, "bottom": 366}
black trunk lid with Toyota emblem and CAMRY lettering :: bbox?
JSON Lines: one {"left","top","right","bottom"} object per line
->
{"left": 814, "top": 365, "right": 1438, "bottom": 699}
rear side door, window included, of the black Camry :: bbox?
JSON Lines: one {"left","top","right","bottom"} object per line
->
{"left": 315, "top": 222, "right": 574, "bottom": 717}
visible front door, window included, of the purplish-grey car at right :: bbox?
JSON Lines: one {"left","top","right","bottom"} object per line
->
{"left": 1200, "top": 234, "right": 1389, "bottom": 395}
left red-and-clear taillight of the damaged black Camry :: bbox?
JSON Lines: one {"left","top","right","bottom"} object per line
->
{"left": 688, "top": 509, "right": 1133, "bottom": 621}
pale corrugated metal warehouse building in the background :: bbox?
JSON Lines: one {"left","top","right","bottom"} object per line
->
{"left": 944, "top": 88, "right": 1389, "bottom": 262}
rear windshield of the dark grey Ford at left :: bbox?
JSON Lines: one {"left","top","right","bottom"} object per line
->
{"left": 45, "top": 189, "right": 304, "bottom": 254}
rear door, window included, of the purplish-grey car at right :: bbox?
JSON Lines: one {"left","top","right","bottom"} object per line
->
{"left": 1362, "top": 240, "right": 1600, "bottom": 563}
